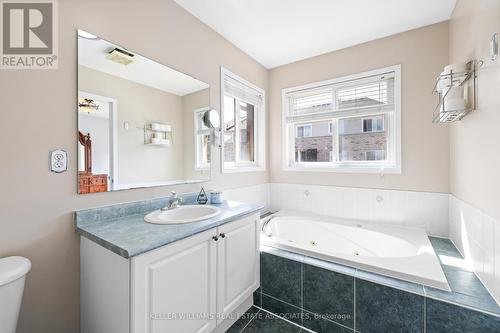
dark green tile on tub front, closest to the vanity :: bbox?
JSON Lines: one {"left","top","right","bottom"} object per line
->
{"left": 260, "top": 252, "right": 302, "bottom": 308}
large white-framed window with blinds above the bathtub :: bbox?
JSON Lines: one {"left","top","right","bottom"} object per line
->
{"left": 283, "top": 65, "right": 401, "bottom": 173}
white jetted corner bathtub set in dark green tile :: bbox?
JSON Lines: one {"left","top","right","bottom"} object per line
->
{"left": 261, "top": 211, "right": 450, "bottom": 291}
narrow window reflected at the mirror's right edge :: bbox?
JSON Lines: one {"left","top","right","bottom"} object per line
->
{"left": 194, "top": 108, "right": 210, "bottom": 170}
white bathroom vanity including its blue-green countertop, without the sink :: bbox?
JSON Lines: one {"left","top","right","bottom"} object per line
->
{"left": 75, "top": 199, "right": 262, "bottom": 333}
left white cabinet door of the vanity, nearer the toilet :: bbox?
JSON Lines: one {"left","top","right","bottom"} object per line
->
{"left": 131, "top": 229, "right": 217, "bottom": 333}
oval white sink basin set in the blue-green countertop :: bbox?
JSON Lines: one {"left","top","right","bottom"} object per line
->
{"left": 144, "top": 205, "right": 220, "bottom": 224}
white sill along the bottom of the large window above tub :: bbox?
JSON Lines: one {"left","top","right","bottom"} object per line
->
{"left": 283, "top": 163, "right": 402, "bottom": 174}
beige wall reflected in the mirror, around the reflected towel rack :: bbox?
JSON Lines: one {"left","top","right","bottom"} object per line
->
{"left": 78, "top": 65, "right": 188, "bottom": 186}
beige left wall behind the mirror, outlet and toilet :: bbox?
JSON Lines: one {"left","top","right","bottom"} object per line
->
{"left": 0, "top": 0, "right": 268, "bottom": 333}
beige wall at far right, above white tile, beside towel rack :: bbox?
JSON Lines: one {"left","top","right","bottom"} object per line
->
{"left": 450, "top": 0, "right": 500, "bottom": 220}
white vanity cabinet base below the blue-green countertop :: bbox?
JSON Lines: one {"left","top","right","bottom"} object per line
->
{"left": 81, "top": 214, "right": 260, "bottom": 333}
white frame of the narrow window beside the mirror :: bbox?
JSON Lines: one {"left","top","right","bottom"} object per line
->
{"left": 220, "top": 66, "right": 266, "bottom": 173}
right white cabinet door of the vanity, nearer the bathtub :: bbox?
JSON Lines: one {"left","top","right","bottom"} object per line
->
{"left": 217, "top": 215, "right": 260, "bottom": 319}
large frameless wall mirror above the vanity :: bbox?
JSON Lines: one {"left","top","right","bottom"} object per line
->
{"left": 77, "top": 30, "right": 211, "bottom": 194}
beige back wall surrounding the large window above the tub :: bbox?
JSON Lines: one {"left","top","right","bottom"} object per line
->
{"left": 269, "top": 22, "right": 449, "bottom": 192}
